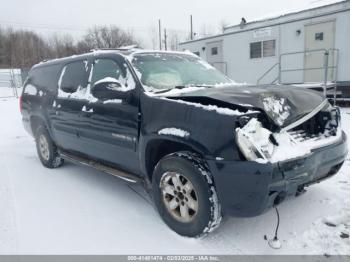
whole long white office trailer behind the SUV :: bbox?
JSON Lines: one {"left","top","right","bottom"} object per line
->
{"left": 180, "top": 0, "right": 350, "bottom": 98}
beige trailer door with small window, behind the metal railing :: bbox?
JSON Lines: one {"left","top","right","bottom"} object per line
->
{"left": 304, "top": 21, "right": 335, "bottom": 82}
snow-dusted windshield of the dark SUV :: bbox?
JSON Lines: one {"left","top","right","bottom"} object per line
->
{"left": 132, "top": 53, "right": 234, "bottom": 91}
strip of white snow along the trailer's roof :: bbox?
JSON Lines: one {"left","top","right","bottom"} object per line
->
{"left": 224, "top": 0, "right": 350, "bottom": 31}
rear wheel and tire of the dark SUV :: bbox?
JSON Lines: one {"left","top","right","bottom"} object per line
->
{"left": 35, "top": 126, "right": 64, "bottom": 168}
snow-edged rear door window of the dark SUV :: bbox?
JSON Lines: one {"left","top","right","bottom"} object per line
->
{"left": 58, "top": 61, "right": 89, "bottom": 94}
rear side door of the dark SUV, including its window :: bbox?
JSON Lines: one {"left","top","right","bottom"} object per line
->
{"left": 51, "top": 60, "right": 90, "bottom": 152}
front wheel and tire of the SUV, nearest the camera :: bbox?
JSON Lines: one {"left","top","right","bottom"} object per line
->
{"left": 152, "top": 152, "right": 221, "bottom": 237}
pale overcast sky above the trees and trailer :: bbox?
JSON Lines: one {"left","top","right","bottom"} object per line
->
{"left": 0, "top": 0, "right": 339, "bottom": 47}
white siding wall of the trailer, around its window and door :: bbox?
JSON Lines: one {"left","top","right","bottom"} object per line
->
{"left": 180, "top": 1, "right": 350, "bottom": 84}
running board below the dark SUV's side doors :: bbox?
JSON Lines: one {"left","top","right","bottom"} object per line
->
{"left": 59, "top": 150, "right": 144, "bottom": 183}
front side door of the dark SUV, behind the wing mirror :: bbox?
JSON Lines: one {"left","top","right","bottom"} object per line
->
{"left": 81, "top": 58, "right": 139, "bottom": 172}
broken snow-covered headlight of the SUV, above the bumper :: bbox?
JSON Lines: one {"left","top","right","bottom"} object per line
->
{"left": 236, "top": 118, "right": 274, "bottom": 161}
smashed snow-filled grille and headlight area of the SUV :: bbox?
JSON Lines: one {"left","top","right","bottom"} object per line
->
{"left": 236, "top": 100, "right": 342, "bottom": 163}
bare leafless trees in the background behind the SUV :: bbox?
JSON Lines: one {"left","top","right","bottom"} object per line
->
{"left": 0, "top": 26, "right": 139, "bottom": 69}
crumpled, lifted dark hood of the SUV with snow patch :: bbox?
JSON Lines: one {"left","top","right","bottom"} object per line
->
{"left": 164, "top": 85, "right": 324, "bottom": 127}
